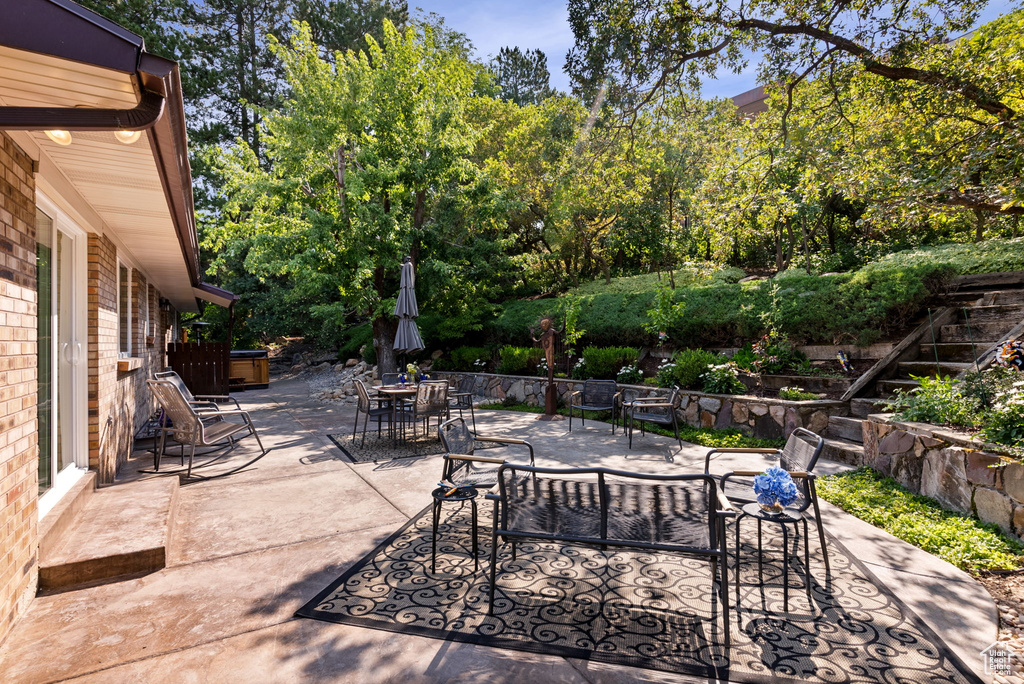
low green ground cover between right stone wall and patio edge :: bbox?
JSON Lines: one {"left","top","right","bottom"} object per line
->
{"left": 817, "top": 467, "right": 1021, "bottom": 572}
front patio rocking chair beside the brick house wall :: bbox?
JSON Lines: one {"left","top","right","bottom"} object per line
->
{"left": 146, "top": 380, "right": 267, "bottom": 479}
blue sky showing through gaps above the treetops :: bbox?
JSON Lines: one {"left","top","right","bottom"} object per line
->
{"left": 409, "top": 0, "right": 1019, "bottom": 97}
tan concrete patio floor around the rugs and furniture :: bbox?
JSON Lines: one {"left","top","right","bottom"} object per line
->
{"left": 0, "top": 380, "right": 997, "bottom": 684}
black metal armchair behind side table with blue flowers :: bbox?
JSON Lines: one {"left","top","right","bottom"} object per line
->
{"left": 705, "top": 428, "right": 829, "bottom": 570}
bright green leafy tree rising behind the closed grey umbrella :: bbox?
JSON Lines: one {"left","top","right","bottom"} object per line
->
{"left": 212, "top": 22, "right": 491, "bottom": 372}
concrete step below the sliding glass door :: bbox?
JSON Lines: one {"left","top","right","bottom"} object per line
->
{"left": 39, "top": 477, "right": 178, "bottom": 593}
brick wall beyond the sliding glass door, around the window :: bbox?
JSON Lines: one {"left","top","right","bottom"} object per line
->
{"left": 88, "top": 234, "right": 172, "bottom": 484}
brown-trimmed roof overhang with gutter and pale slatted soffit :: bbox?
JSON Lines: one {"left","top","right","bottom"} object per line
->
{"left": 0, "top": 0, "right": 233, "bottom": 311}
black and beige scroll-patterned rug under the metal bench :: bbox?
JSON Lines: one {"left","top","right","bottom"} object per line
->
{"left": 296, "top": 502, "right": 981, "bottom": 684}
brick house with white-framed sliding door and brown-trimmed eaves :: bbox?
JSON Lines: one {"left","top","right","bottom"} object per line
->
{"left": 0, "top": 0, "right": 233, "bottom": 643}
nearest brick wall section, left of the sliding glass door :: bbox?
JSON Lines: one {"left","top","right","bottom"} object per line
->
{"left": 0, "top": 132, "right": 39, "bottom": 641}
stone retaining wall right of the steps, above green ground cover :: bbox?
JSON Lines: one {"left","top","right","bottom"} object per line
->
{"left": 863, "top": 415, "right": 1024, "bottom": 539}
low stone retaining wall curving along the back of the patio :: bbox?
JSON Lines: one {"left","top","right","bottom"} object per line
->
{"left": 431, "top": 372, "right": 849, "bottom": 438}
